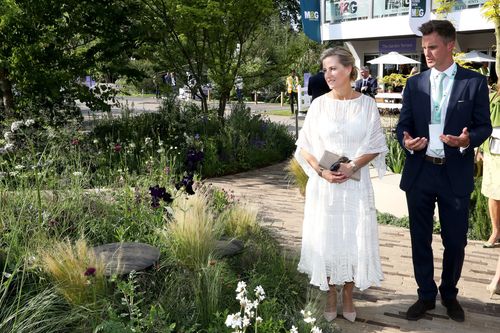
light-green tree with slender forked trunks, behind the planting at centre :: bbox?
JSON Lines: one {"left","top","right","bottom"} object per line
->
{"left": 142, "top": 0, "right": 273, "bottom": 118}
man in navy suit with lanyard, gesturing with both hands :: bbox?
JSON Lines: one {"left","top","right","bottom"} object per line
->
{"left": 396, "top": 20, "right": 492, "bottom": 322}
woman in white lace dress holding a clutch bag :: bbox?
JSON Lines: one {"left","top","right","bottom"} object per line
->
{"left": 295, "top": 47, "right": 387, "bottom": 322}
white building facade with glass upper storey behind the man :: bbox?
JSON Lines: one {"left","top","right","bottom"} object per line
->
{"left": 320, "top": 0, "right": 496, "bottom": 78}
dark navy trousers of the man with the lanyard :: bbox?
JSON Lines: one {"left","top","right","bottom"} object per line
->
{"left": 406, "top": 161, "right": 470, "bottom": 300}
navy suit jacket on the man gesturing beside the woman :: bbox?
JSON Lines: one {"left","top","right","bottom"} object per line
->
{"left": 396, "top": 65, "right": 492, "bottom": 196}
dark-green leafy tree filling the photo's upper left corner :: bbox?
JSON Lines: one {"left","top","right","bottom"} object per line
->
{"left": 0, "top": 0, "right": 142, "bottom": 124}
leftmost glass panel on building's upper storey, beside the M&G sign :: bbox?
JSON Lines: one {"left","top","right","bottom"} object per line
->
{"left": 325, "top": 0, "right": 372, "bottom": 23}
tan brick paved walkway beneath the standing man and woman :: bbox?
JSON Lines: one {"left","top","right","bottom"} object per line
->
{"left": 209, "top": 163, "right": 500, "bottom": 333}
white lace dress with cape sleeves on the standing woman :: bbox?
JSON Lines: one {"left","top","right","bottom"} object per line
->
{"left": 295, "top": 94, "right": 387, "bottom": 291}
